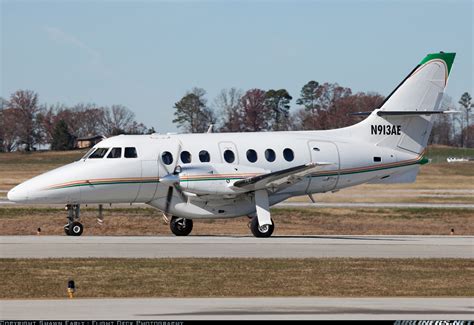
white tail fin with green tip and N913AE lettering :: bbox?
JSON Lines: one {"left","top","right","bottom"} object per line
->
{"left": 349, "top": 52, "right": 456, "bottom": 154}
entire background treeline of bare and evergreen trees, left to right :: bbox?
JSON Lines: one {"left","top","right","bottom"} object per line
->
{"left": 0, "top": 85, "right": 474, "bottom": 152}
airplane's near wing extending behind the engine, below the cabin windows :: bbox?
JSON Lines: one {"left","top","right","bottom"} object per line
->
{"left": 233, "top": 162, "right": 332, "bottom": 192}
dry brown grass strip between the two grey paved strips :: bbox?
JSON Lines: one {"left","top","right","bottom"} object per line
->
{"left": 0, "top": 258, "right": 474, "bottom": 299}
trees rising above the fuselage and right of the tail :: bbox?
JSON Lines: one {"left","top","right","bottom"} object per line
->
{"left": 173, "top": 80, "right": 474, "bottom": 147}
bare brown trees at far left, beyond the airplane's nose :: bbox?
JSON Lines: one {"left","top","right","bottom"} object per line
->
{"left": 0, "top": 90, "right": 154, "bottom": 152}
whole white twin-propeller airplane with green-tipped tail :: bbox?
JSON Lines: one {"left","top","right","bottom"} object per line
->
{"left": 8, "top": 52, "right": 455, "bottom": 237}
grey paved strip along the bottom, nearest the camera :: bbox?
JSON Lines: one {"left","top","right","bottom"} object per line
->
{"left": 0, "top": 297, "right": 474, "bottom": 320}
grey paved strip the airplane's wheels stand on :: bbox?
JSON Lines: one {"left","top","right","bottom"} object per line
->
{"left": 0, "top": 236, "right": 474, "bottom": 258}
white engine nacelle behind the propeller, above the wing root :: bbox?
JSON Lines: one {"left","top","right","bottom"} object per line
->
{"left": 179, "top": 164, "right": 269, "bottom": 195}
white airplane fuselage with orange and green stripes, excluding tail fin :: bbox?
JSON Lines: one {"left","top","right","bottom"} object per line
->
{"left": 9, "top": 128, "right": 421, "bottom": 218}
